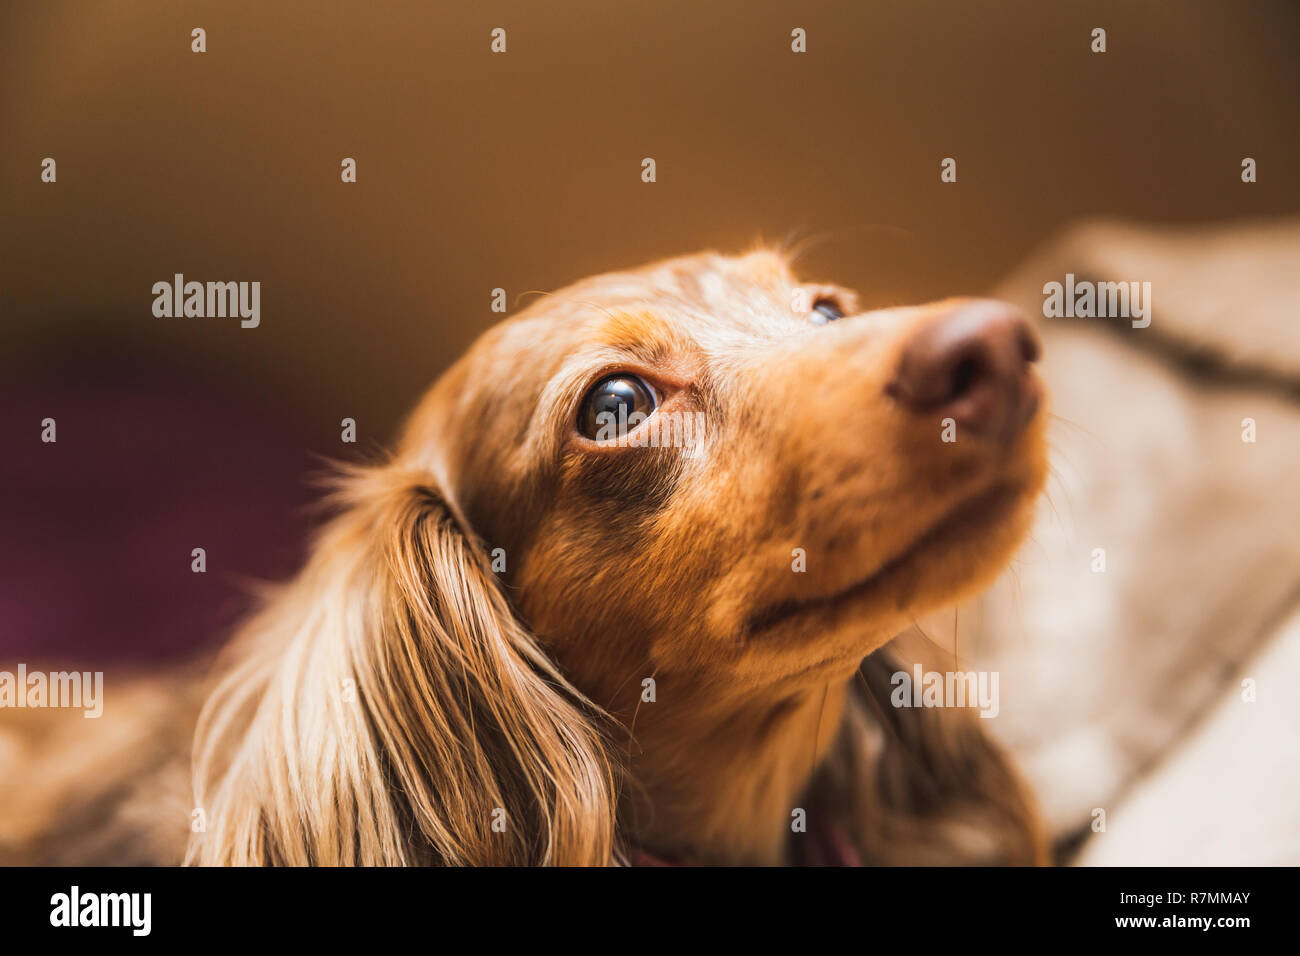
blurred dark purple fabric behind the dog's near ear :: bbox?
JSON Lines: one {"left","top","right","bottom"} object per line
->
{"left": 0, "top": 362, "right": 335, "bottom": 662}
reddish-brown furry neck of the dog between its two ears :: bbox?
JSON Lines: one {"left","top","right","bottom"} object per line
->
{"left": 621, "top": 680, "right": 848, "bottom": 865}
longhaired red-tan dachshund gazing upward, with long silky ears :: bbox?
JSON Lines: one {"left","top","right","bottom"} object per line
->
{"left": 2, "top": 250, "right": 1047, "bottom": 865}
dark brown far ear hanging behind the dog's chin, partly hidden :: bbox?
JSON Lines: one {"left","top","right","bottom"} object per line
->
{"left": 814, "top": 645, "right": 1048, "bottom": 865}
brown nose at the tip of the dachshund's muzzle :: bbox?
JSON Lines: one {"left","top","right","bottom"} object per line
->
{"left": 887, "top": 299, "right": 1039, "bottom": 441}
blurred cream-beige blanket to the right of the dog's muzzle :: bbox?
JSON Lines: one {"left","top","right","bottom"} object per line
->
{"left": 945, "top": 221, "right": 1300, "bottom": 864}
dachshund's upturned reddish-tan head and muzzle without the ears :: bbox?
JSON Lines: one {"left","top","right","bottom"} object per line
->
{"left": 402, "top": 252, "right": 1045, "bottom": 711}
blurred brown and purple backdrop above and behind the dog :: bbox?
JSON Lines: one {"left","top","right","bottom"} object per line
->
{"left": 0, "top": 0, "right": 1300, "bottom": 661}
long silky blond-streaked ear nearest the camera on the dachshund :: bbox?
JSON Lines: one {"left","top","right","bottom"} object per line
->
{"left": 189, "top": 467, "right": 615, "bottom": 865}
